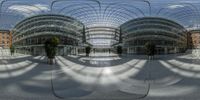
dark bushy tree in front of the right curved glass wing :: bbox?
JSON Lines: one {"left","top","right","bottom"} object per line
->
{"left": 145, "top": 42, "right": 156, "bottom": 59}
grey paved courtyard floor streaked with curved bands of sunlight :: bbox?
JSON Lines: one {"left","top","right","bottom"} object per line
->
{"left": 0, "top": 51, "right": 200, "bottom": 100}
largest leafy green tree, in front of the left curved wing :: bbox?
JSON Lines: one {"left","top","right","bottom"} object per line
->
{"left": 45, "top": 37, "right": 59, "bottom": 65}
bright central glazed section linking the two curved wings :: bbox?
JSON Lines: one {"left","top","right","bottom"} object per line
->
{"left": 85, "top": 27, "right": 120, "bottom": 48}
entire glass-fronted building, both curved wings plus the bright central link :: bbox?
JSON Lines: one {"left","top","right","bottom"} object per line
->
{"left": 13, "top": 14, "right": 191, "bottom": 55}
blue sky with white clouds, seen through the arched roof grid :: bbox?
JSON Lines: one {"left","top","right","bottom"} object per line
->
{"left": 0, "top": 0, "right": 200, "bottom": 29}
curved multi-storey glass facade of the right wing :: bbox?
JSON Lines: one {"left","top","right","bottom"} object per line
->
{"left": 120, "top": 17, "right": 187, "bottom": 54}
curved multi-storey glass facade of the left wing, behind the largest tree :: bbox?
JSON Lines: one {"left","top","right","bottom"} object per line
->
{"left": 13, "top": 14, "right": 84, "bottom": 55}
